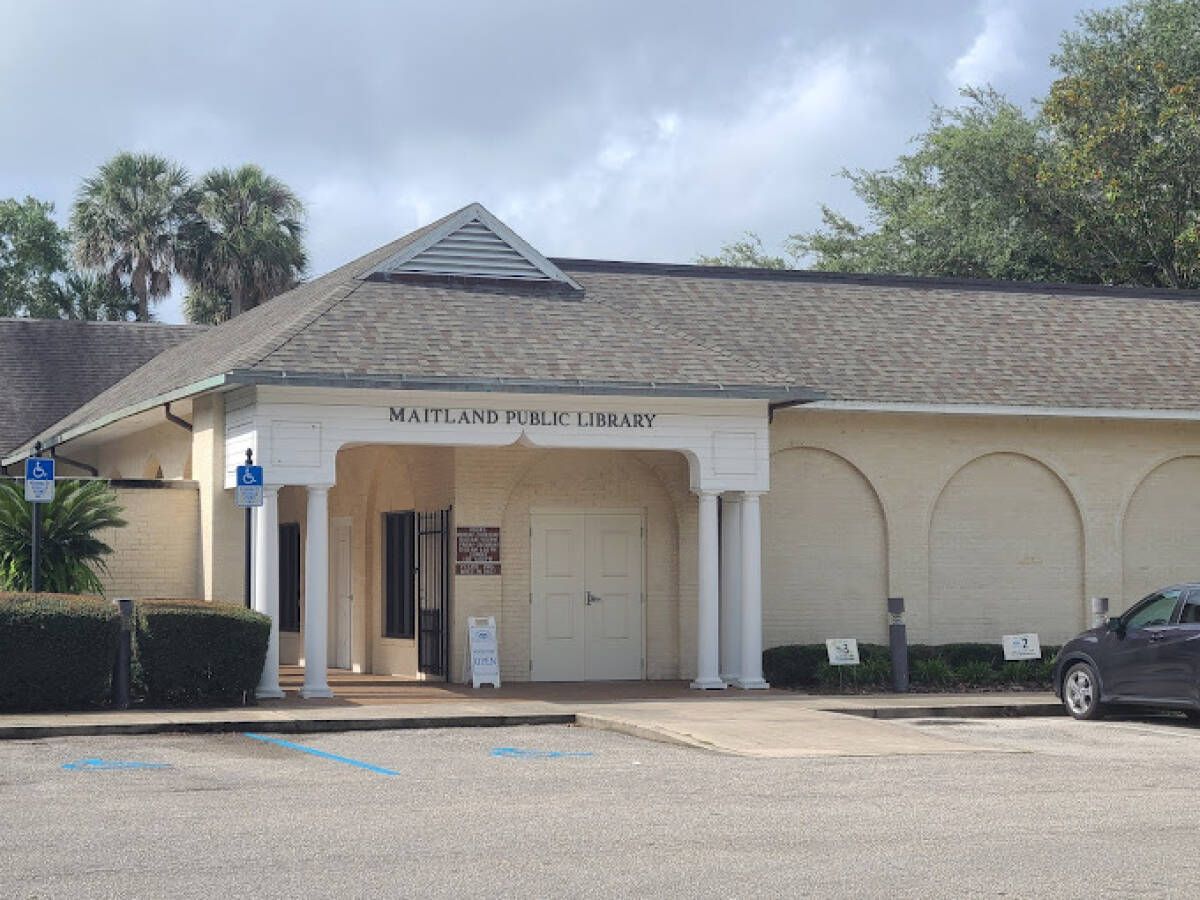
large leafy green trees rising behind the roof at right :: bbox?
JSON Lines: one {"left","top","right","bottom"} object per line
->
{"left": 722, "top": 0, "right": 1200, "bottom": 287}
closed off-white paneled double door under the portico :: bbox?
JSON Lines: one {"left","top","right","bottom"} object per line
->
{"left": 529, "top": 511, "right": 643, "bottom": 682}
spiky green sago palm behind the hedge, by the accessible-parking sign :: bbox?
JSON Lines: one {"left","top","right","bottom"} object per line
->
{"left": 0, "top": 480, "right": 125, "bottom": 594}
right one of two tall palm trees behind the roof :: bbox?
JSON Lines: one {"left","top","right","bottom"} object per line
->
{"left": 180, "top": 164, "right": 308, "bottom": 323}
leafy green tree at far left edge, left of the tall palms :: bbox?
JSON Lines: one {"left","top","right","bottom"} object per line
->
{"left": 0, "top": 197, "right": 67, "bottom": 316}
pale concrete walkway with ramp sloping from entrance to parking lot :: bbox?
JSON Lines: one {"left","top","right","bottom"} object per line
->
{"left": 0, "top": 677, "right": 1062, "bottom": 757}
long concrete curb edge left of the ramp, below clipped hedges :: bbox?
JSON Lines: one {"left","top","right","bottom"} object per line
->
{"left": 0, "top": 713, "right": 575, "bottom": 740}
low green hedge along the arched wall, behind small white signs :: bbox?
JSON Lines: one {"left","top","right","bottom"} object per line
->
{"left": 762, "top": 643, "right": 1058, "bottom": 690}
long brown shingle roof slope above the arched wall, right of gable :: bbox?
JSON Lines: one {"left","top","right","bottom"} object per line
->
{"left": 556, "top": 259, "right": 1200, "bottom": 410}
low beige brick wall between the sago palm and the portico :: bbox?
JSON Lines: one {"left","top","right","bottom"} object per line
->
{"left": 101, "top": 482, "right": 202, "bottom": 598}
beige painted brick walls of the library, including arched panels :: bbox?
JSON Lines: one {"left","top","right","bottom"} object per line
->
{"left": 91, "top": 400, "right": 1200, "bottom": 679}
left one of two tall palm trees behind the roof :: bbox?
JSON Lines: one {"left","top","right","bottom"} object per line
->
{"left": 71, "top": 154, "right": 193, "bottom": 322}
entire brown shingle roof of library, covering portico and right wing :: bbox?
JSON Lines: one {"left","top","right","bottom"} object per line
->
{"left": 11, "top": 214, "right": 1200, "bottom": 458}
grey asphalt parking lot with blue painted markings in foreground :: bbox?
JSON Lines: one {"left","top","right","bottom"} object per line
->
{"left": 0, "top": 719, "right": 1200, "bottom": 898}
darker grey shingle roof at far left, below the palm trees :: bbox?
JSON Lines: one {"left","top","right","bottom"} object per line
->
{"left": 0, "top": 318, "right": 206, "bottom": 456}
